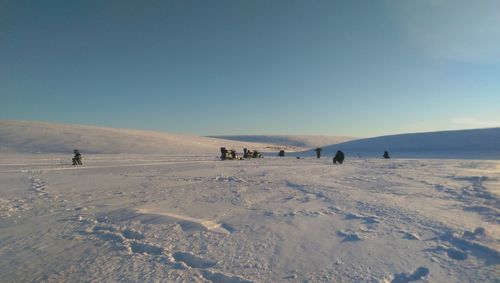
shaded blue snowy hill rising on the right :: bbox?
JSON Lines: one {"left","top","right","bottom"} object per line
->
{"left": 316, "top": 128, "right": 500, "bottom": 159}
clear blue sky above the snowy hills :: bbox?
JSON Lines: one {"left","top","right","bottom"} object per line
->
{"left": 0, "top": 0, "right": 500, "bottom": 136}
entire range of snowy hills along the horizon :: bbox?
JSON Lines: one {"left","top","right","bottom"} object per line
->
{"left": 0, "top": 121, "right": 500, "bottom": 159}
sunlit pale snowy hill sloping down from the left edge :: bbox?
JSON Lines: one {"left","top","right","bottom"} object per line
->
{"left": 0, "top": 121, "right": 286, "bottom": 155}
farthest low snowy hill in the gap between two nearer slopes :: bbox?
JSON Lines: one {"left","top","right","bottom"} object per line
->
{"left": 212, "top": 135, "right": 356, "bottom": 148}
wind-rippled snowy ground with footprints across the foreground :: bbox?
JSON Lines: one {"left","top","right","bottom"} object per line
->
{"left": 0, "top": 155, "right": 500, "bottom": 283}
